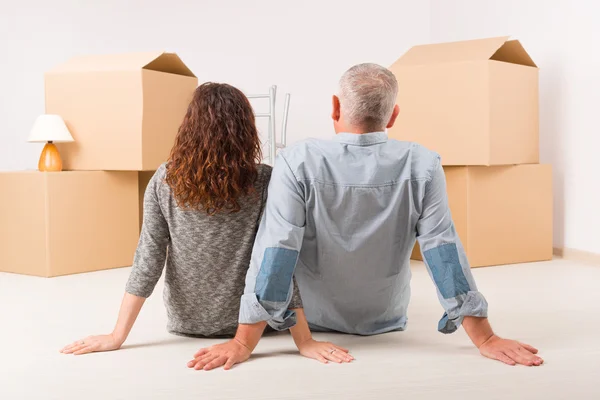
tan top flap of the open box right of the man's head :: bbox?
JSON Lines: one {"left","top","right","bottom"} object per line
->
{"left": 394, "top": 36, "right": 509, "bottom": 65}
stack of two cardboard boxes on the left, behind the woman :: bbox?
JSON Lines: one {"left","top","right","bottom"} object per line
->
{"left": 0, "top": 53, "right": 198, "bottom": 276}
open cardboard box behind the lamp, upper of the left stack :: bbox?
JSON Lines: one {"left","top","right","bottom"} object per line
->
{"left": 45, "top": 53, "right": 198, "bottom": 171}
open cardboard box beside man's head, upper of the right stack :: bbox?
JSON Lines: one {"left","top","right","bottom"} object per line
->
{"left": 389, "top": 36, "right": 539, "bottom": 165}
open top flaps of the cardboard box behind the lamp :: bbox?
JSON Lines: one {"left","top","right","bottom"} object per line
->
{"left": 48, "top": 51, "right": 195, "bottom": 77}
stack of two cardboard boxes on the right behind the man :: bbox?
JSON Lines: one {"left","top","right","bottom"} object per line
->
{"left": 389, "top": 37, "right": 552, "bottom": 267}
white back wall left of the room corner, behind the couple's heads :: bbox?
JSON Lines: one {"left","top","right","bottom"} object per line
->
{"left": 0, "top": 0, "right": 429, "bottom": 170}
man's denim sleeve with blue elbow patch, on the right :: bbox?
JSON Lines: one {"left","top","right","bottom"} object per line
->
{"left": 417, "top": 158, "right": 488, "bottom": 333}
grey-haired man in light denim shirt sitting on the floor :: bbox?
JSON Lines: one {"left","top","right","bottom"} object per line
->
{"left": 190, "top": 64, "right": 543, "bottom": 369}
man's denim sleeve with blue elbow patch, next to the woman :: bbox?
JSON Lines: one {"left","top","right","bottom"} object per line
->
{"left": 239, "top": 154, "right": 306, "bottom": 330}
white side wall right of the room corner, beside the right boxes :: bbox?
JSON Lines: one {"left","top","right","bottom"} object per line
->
{"left": 431, "top": 0, "right": 600, "bottom": 253}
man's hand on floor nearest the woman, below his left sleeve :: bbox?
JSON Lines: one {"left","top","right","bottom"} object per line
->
{"left": 187, "top": 339, "right": 252, "bottom": 371}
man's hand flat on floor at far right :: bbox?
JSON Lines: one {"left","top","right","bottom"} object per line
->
{"left": 479, "top": 335, "right": 544, "bottom": 367}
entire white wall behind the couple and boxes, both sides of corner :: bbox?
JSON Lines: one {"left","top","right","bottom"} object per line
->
{"left": 0, "top": 0, "right": 600, "bottom": 253}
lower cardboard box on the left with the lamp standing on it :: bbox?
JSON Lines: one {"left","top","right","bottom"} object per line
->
{"left": 0, "top": 171, "right": 139, "bottom": 277}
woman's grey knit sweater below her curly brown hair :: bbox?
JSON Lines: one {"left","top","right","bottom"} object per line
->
{"left": 126, "top": 164, "right": 302, "bottom": 337}
